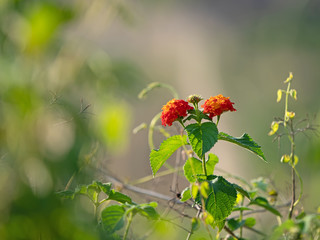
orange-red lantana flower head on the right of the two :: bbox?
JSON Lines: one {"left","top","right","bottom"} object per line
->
{"left": 201, "top": 94, "right": 236, "bottom": 118}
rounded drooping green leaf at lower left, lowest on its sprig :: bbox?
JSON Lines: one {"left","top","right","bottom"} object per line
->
{"left": 101, "top": 205, "right": 125, "bottom": 233}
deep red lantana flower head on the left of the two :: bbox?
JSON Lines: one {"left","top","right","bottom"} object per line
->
{"left": 161, "top": 99, "right": 193, "bottom": 126}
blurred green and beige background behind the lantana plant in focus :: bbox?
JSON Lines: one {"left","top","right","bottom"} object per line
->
{"left": 0, "top": 0, "right": 320, "bottom": 239}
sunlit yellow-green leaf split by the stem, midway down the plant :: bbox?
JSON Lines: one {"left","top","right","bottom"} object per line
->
{"left": 183, "top": 153, "right": 219, "bottom": 183}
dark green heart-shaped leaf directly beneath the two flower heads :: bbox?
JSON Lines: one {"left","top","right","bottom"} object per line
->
{"left": 186, "top": 122, "right": 218, "bottom": 158}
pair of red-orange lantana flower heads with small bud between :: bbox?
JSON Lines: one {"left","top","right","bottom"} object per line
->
{"left": 161, "top": 94, "right": 236, "bottom": 126}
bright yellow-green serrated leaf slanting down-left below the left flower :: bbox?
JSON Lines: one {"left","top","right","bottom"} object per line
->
{"left": 150, "top": 135, "right": 188, "bottom": 176}
